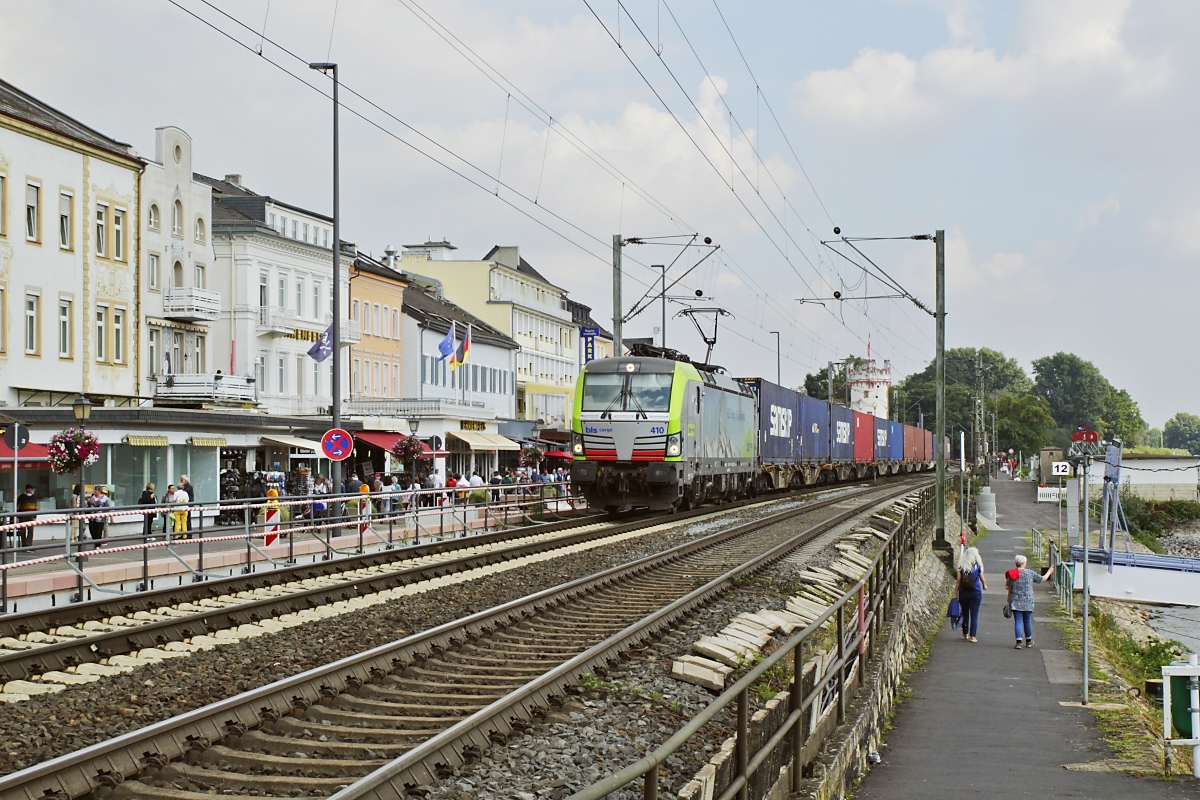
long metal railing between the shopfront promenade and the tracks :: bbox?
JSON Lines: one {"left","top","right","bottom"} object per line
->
{"left": 0, "top": 482, "right": 587, "bottom": 613}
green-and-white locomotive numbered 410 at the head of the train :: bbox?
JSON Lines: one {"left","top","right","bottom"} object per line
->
{"left": 571, "top": 356, "right": 758, "bottom": 511}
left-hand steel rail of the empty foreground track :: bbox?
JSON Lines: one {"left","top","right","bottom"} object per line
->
{"left": 0, "top": 486, "right": 912, "bottom": 800}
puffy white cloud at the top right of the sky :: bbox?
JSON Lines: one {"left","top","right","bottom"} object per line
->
{"left": 796, "top": 0, "right": 1171, "bottom": 133}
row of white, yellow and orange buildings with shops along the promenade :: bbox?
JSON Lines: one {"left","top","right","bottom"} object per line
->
{"left": 0, "top": 76, "right": 611, "bottom": 507}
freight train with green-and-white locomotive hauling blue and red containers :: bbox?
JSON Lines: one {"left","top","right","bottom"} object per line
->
{"left": 570, "top": 355, "right": 936, "bottom": 511}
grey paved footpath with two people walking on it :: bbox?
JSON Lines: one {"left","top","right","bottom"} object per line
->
{"left": 854, "top": 479, "right": 1200, "bottom": 800}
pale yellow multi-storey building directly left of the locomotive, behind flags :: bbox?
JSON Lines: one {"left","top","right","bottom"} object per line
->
{"left": 397, "top": 241, "right": 578, "bottom": 428}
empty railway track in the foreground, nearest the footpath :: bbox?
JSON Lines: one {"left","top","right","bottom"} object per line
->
{"left": 0, "top": 481, "right": 917, "bottom": 800}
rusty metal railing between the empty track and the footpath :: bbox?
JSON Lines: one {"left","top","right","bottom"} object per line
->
{"left": 569, "top": 489, "right": 932, "bottom": 800}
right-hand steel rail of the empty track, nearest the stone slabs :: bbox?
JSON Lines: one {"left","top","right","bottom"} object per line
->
{"left": 330, "top": 486, "right": 913, "bottom": 800}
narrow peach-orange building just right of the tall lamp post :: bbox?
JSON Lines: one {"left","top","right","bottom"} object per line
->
{"left": 348, "top": 253, "right": 408, "bottom": 402}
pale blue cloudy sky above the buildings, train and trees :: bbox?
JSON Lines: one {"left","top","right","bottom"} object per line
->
{"left": 0, "top": 0, "right": 1200, "bottom": 426}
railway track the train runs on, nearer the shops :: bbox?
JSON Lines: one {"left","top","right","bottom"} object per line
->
{"left": 0, "top": 482, "right": 888, "bottom": 697}
